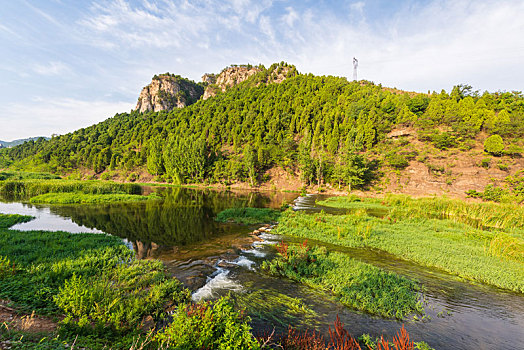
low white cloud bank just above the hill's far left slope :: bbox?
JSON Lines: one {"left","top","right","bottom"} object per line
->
{"left": 0, "top": 98, "right": 135, "bottom": 141}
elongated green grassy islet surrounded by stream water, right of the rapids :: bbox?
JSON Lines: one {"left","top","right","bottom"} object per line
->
{"left": 262, "top": 243, "right": 424, "bottom": 319}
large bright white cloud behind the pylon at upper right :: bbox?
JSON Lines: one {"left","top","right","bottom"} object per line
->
{"left": 274, "top": 1, "right": 524, "bottom": 91}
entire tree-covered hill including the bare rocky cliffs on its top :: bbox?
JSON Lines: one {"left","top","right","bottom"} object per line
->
{"left": 0, "top": 62, "right": 524, "bottom": 200}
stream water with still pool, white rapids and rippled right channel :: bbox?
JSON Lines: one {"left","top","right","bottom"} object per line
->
{"left": 0, "top": 188, "right": 524, "bottom": 349}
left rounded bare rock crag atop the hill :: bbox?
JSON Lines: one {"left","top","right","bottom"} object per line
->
{"left": 135, "top": 73, "right": 204, "bottom": 112}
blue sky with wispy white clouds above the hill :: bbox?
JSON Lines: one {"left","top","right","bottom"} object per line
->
{"left": 0, "top": 0, "right": 524, "bottom": 141}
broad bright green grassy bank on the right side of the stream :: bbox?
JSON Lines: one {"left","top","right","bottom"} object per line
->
{"left": 277, "top": 196, "right": 524, "bottom": 293}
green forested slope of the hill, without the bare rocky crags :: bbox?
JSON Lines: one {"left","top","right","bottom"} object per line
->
{"left": 0, "top": 63, "right": 524, "bottom": 200}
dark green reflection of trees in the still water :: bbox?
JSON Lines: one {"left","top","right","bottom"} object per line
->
{"left": 47, "top": 188, "right": 297, "bottom": 259}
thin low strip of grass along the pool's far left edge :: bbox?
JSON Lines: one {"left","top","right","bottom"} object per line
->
{"left": 29, "top": 192, "right": 152, "bottom": 204}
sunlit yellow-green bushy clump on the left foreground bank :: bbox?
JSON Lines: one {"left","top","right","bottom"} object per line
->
{"left": 54, "top": 260, "right": 190, "bottom": 334}
